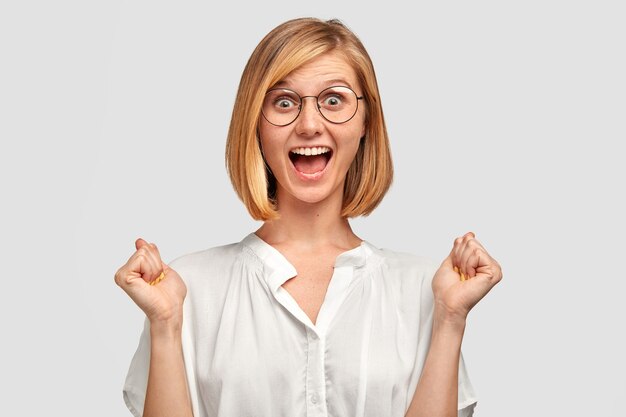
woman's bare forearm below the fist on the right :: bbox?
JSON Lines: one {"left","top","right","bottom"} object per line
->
{"left": 406, "top": 315, "right": 465, "bottom": 417}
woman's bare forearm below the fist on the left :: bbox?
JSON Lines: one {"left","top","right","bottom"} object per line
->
{"left": 143, "top": 323, "right": 193, "bottom": 417}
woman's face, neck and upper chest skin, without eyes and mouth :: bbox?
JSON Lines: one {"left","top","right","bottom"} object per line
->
{"left": 256, "top": 54, "right": 365, "bottom": 323}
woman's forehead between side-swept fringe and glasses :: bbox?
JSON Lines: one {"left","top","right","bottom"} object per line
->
{"left": 275, "top": 52, "right": 360, "bottom": 93}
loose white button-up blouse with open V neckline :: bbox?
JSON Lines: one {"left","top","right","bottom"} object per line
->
{"left": 123, "top": 233, "right": 476, "bottom": 417}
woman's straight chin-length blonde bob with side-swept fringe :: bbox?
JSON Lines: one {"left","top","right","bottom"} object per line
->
{"left": 226, "top": 18, "right": 393, "bottom": 221}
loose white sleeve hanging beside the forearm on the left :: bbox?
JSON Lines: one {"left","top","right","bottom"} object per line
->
{"left": 122, "top": 317, "right": 150, "bottom": 417}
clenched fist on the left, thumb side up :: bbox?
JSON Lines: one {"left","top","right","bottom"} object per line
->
{"left": 115, "top": 238, "right": 187, "bottom": 324}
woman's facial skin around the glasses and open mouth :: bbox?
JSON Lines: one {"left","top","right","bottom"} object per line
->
{"left": 259, "top": 53, "right": 365, "bottom": 208}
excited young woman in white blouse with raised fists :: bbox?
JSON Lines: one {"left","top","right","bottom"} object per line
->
{"left": 115, "top": 19, "right": 502, "bottom": 417}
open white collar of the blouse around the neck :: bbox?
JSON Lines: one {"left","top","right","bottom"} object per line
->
{"left": 242, "top": 233, "right": 372, "bottom": 291}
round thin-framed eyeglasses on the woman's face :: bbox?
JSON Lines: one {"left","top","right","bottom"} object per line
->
{"left": 261, "top": 86, "right": 363, "bottom": 126}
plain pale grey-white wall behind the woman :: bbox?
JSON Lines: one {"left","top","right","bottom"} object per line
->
{"left": 0, "top": 0, "right": 626, "bottom": 417}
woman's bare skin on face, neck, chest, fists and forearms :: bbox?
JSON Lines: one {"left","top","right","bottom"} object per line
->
{"left": 115, "top": 53, "right": 502, "bottom": 417}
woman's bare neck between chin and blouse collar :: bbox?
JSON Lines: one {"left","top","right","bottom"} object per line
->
{"left": 256, "top": 184, "right": 361, "bottom": 249}
